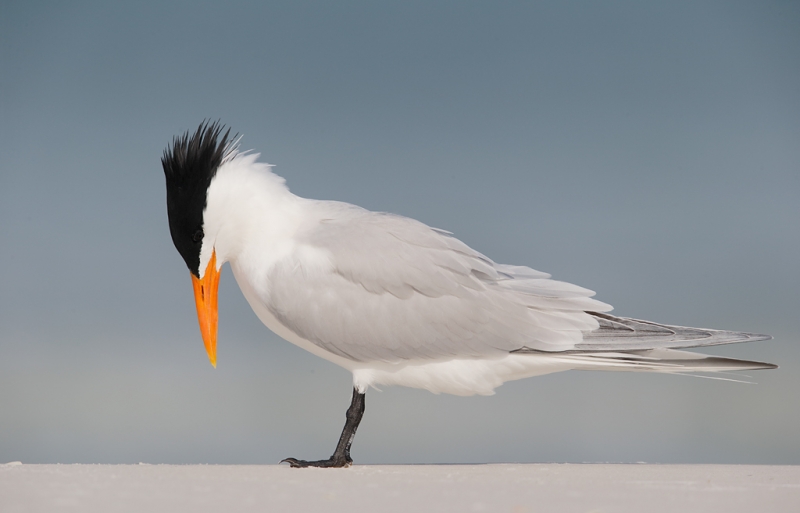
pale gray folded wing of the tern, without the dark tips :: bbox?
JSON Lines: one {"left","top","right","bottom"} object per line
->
{"left": 267, "top": 202, "right": 611, "bottom": 362}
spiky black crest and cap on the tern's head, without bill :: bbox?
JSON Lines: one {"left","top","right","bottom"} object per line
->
{"left": 161, "top": 121, "right": 234, "bottom": 277}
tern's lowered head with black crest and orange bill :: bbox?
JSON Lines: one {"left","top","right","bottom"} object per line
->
{"left": 161, "top": 122, "right": 236, "bottom": 367}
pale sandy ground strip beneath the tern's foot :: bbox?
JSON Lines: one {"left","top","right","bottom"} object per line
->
{"left": 0, "top": 463, "right": 800, "bottom": 513}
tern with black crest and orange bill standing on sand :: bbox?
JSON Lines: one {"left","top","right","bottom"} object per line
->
{"left": 161, "top": 120, "right": 777, "bottom": 467}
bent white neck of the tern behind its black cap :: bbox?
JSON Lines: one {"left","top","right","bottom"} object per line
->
{"left": 200, "top": 154, "right": 303, "bottom": 269}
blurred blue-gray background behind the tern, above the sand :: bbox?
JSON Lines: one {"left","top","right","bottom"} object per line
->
{"left": 0, "top": 1, "right": 800, "bottom": 464}
